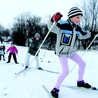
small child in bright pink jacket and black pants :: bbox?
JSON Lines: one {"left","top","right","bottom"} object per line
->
{"left": 7, "top": 43, "right": 19, "bottom": 64}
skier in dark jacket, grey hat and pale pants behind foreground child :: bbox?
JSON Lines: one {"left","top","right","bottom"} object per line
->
{"left": 24, "top": 33, "right": 42, "bottom": 70}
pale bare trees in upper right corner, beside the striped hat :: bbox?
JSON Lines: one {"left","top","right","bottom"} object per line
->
{"left": 82, "top": 0, "right": 98, "bottom": 31}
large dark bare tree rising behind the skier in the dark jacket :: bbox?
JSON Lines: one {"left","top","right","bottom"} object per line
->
{"left": 12, "top": 12, "right": 41, "bottom": 45}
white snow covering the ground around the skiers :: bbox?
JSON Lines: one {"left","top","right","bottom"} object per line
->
{"left": 0, "top": 43, "right": 98, "bottom": 98}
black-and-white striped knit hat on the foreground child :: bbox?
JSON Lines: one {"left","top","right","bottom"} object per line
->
{"left": 68, "top": 7, "right": 83, "bottom": 18}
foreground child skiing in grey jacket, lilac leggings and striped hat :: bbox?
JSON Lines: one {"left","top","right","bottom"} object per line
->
{"left": 47, "top": 7, "right": 91, "bottom": 98}
